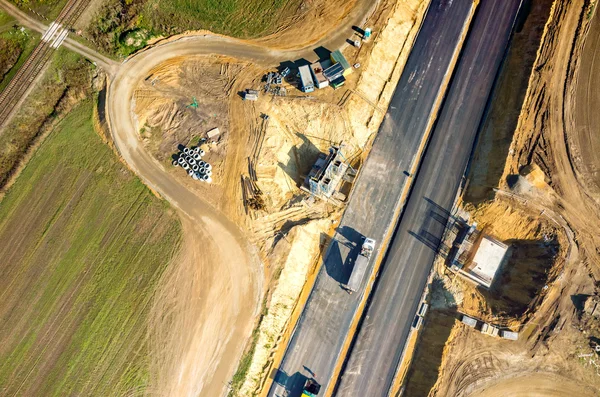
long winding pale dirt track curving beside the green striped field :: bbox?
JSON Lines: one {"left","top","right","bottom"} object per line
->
{"left": 106, "top": 0, "right": 376, "bottom": 396}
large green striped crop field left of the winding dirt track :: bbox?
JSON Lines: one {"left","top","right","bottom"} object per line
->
{"left": 0, "top": 100, "right": 181, "bottom": 396}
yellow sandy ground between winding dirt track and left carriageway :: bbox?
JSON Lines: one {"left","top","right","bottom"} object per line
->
{"left": 123, "top": 0, "right": 426, "bottom": 395}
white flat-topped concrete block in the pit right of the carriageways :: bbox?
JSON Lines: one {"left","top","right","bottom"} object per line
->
{"left": 459, "top": 235, "right": 508, "bottom": 288}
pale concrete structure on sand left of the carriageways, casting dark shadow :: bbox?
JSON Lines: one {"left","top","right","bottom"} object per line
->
{"left": 303, "top": 146, "right": 348, "bottom": 199}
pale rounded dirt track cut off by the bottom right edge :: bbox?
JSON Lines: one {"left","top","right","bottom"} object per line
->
{"left": 469, "top": 374, "right": 595, "bottom": 397}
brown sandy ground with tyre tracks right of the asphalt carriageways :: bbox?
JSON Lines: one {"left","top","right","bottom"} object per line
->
{"left": 400, "top": 1, "right": 600, "bottom": 396}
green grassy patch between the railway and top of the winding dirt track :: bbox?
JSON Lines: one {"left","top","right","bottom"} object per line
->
{"left": 87, "top": 0, "right": 301, "bottom": 56}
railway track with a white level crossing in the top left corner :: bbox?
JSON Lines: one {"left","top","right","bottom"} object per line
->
{"left": 0, "top": 0, "right": 89, "bottom": 128}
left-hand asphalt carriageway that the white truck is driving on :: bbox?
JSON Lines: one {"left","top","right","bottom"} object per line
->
{"left": 269, "top": 0, "right": 473, "bottom": 397}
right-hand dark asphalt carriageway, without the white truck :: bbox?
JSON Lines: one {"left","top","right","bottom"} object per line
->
{"left": 336, "top": 0, "right": 521, "bottom": 396}
